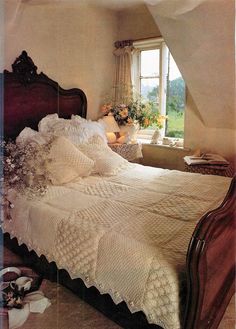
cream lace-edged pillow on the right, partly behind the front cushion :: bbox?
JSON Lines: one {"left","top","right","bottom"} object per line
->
{"left": 76, "top": 136, "right": 129, "bottom": 176}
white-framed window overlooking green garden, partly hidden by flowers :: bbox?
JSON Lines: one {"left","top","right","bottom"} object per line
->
{"left": 133, "top": 39, "right": 185, "bottom": 139}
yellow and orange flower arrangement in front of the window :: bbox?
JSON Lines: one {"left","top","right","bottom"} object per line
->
{"left": 101, "top": 100, "right": 167, "bottom": 129}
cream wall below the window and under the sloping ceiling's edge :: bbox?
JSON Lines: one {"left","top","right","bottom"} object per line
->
{"left": 143, "top": 88, "right": 236, "bottom": 170}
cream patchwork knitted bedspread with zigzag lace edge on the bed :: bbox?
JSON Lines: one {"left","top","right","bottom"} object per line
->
{"left": 4, "top": 164, "right": 230, "bottom": 329}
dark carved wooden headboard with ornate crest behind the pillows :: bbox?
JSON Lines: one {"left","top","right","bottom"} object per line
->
{"left": 3, "top": 51, "right": 87, "bottom": 139}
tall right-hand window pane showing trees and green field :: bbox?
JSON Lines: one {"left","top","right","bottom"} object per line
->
{"left": 166, "top": 54, "right": 185, "bottom": 138}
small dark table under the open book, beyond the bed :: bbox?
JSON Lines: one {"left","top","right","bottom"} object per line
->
{"left": 184, "top": 162, "right": 234, "bottom": 177}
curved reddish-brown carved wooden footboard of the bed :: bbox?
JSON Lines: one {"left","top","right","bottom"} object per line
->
{"left": 184, "top": 176, "right": 236, "bottom": 329}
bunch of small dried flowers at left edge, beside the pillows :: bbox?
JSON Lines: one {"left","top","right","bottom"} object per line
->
{"left": 0, "top": 141, "right": 50, "bottom": 197}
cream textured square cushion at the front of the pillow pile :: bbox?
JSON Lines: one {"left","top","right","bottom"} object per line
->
{"left": 47, "top": 137, "right": 94, "bottom": 185}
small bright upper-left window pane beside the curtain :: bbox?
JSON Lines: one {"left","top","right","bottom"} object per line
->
{"left": 141, "top": 49, "right": 160, "bottom": 77}
